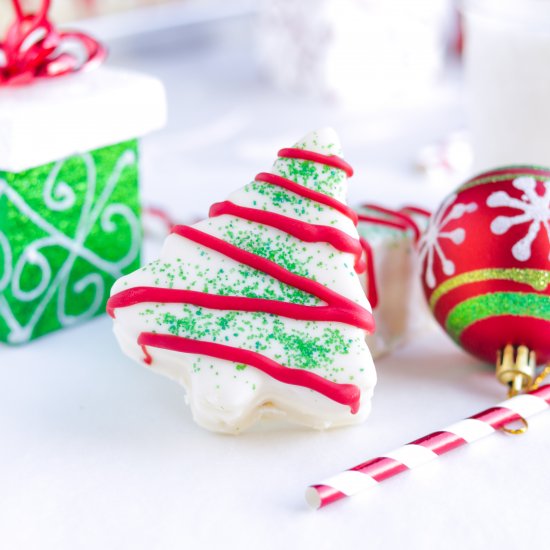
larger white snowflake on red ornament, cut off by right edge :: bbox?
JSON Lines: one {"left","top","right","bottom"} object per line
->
{"left": 487, "top": 176, "right": 550, "bottom": 262}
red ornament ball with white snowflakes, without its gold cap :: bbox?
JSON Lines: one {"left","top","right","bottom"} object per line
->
{"left": 419, "top": 166, "right": 550, "bottom": 364}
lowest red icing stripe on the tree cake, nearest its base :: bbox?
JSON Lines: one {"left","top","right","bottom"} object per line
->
{"left": 138, "top": 332, "right": 361, "bottom": 414}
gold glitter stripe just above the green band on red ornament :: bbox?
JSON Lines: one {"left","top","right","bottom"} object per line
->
{"left": 430, "top": 268, "right": 550, "bottom": 311}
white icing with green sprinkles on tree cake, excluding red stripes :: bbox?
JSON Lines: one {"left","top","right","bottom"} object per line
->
{"left": 112, "top": 129, "right": 376, "bottom": 433}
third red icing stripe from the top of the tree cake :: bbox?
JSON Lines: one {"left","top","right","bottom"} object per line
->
{"left": 209, "top": 201, "right": 364, "bottom": 273}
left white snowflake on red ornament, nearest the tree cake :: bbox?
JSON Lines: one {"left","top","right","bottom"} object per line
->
{"left": 418, "top": 193, "right": 477, "bottom": 288}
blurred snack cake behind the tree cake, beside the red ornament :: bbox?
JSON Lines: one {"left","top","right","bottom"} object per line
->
{"left": 357, "top": 204, "right": 433, "bottom": 358}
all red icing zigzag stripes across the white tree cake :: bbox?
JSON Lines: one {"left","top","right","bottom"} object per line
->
{"left": 107, "top": 149, "right": 374, "bottom": 413}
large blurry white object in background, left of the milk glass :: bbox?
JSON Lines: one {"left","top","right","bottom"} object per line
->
{"left": 258, "top": 0, "right": 450, "bottom": 108}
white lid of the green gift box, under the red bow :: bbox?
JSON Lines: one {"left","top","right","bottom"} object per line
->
{"left": 0, "top": 67, "right": 166, "bottom": 172}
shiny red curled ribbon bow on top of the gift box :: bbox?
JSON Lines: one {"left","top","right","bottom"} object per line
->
{"left": 0, "top": 0, "right": 107, "bottom": 86}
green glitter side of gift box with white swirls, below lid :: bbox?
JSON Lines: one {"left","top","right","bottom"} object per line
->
{"left": 0, "top": 140, "right": 141, "bottom": 344}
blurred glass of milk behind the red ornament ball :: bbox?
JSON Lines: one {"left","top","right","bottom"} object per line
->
{"left": 463, "top": 0, "right": 550, "bottom": 171}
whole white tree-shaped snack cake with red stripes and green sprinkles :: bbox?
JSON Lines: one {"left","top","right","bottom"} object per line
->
{"left": 108, "top": 129, "right": 376, "bottom": 433}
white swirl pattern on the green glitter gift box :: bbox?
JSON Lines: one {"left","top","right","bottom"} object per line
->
{"left": 0, "top": 149, "right": 141, "bottom": 343}
